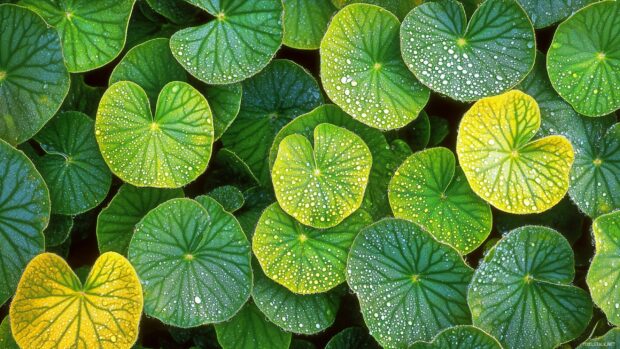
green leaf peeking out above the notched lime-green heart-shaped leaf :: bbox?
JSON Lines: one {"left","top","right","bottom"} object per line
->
{"left": 109, "top": 38, "right": 187, "bottom": 105}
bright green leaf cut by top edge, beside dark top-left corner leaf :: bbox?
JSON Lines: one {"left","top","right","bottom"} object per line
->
{"left": 20, "top": 0, "right": 135, "bottom": 73}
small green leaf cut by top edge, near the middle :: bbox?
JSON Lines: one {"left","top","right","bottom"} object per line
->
{"left": 282, "top": 0, "right": 336, "bottom": 50}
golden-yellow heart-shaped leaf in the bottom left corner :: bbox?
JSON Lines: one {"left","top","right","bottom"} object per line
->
{"left": 10, "top": 252, "right": 142, "bottom": 349}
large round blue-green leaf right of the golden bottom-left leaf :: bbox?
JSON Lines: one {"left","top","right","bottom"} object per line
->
{"left": 128, "top": 196, "right": 252, "bottom": 328}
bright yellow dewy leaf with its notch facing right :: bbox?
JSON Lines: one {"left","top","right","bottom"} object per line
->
{"left": 456, "top": 90, "right": 574, "bottom": 214}
